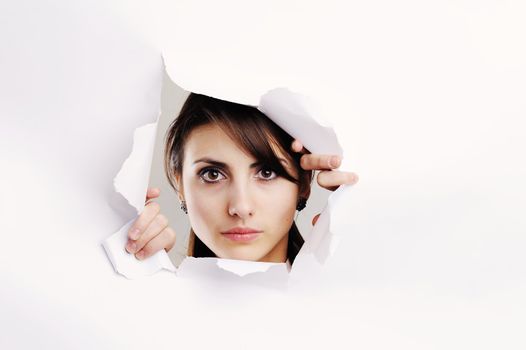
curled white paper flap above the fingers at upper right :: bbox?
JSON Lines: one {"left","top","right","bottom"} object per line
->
{"left": 258, "top": 88, "right": 343, "bottom": 156}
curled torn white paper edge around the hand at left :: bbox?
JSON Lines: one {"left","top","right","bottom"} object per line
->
{"left": 102, "top": 123, "right": 175, "bottom": 279}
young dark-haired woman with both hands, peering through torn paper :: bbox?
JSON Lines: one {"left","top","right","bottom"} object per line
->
{"left": 126, "top": 93, "right": 357, "bottom": 263}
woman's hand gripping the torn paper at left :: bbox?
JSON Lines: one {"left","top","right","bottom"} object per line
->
{"left": 126, "top": 188, "right": 175, "bottom": 260}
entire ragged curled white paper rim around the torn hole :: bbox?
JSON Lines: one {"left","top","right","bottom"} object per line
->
{"left": 104, "top": 77, "right": 350, "bottom": 278}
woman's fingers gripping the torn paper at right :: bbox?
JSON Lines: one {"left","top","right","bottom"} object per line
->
{"left": 292, "top": 140, "right": 358, "bottom": 225}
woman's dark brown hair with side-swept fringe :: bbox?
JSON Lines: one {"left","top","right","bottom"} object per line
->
{"left": 164, "top": 93, "right": 313, "bottom": 263}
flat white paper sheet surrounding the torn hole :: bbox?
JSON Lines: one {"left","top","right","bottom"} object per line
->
{"left": 0, "top": 0, "right": 526, "bottom": 349}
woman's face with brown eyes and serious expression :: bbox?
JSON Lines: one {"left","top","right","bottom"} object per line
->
{"left": 178, "top": 124, "right": 298, "bottom": 262}
